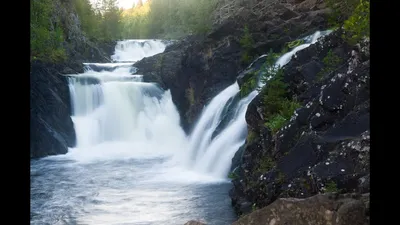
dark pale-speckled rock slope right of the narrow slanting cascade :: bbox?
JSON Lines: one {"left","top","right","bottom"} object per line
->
{"left": 230, "top": 30, "right": 370, "bottom": 214}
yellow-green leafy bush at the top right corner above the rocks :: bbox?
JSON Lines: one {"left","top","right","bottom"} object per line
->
{"left": 343, "top": 0, "right": 370, "bottom": 45}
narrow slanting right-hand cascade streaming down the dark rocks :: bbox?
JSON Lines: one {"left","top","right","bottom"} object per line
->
{"left": 187, "top": 31, "right": 331, "bottom": 178}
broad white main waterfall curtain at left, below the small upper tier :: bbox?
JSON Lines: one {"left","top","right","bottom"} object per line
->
{"left": 67, "top": 71, "right": 192, "bottom": 166}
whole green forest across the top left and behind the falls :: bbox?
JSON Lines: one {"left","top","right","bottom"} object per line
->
{"left": 30, "top": 0, "right": 217, "bottom": 61}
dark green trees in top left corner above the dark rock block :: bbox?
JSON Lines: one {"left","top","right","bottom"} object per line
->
{"left": 30, "top": 0, "right": 66, "bottom": 62}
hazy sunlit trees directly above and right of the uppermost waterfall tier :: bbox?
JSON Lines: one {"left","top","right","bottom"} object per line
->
{"left": 122, "top": 0, "right": 217, "bottom": 39}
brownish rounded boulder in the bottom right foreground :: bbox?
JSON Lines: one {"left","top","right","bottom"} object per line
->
{"left": 232, "top": 194, "right": 369, "bottom": 225}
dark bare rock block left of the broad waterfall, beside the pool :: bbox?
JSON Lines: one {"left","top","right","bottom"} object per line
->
{"left": 30, "top": 62, "right": 76, "bottom": 158}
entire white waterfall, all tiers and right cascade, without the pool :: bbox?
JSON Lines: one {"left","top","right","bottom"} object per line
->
{"left": 64, "top": 31, "right": 329, "bottom": 175}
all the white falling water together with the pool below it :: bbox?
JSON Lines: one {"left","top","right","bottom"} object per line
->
{"left": 31, "top": 33, "right": 332, "bottom": 225}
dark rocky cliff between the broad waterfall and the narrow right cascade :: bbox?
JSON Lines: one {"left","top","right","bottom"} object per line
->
{"left": 134, "top": 0, "right": 329, "bottom": 131}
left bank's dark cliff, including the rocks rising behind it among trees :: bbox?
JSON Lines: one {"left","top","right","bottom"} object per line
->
{"left": 30, "top": 0, "right": 114, "bottom": 158}
